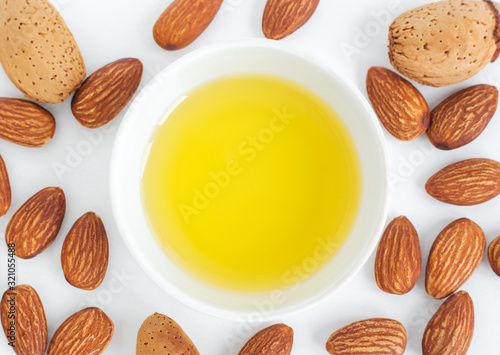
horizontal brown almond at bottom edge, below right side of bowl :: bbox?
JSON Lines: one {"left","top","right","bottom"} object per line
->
{"left": 326, "top": 318, "right": 407, "bottom": 355}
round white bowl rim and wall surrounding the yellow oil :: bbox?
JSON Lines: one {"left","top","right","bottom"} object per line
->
{"left": 110, "top": 40, "right": 388, "bottom": 321}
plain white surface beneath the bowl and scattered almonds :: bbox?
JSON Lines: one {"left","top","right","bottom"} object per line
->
{"left": 0, "top": 0, "right": 500, "bottom": 355}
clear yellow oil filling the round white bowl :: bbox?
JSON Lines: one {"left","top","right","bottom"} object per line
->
{"left": 142, "top": 74, "right": 362, "bottom": 292}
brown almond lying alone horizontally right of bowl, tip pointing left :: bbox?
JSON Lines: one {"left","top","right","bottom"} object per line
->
{"left": 425, "top": 159, "right": 500, "bottom": 206}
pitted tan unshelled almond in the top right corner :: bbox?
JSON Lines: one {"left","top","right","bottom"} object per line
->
{"left": 389, "top": 0, "right": 500, "bottom": 87}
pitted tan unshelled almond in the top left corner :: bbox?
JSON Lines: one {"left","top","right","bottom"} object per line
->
{"left": 0, "top": 0, "right": 86, "bottom": 103}
